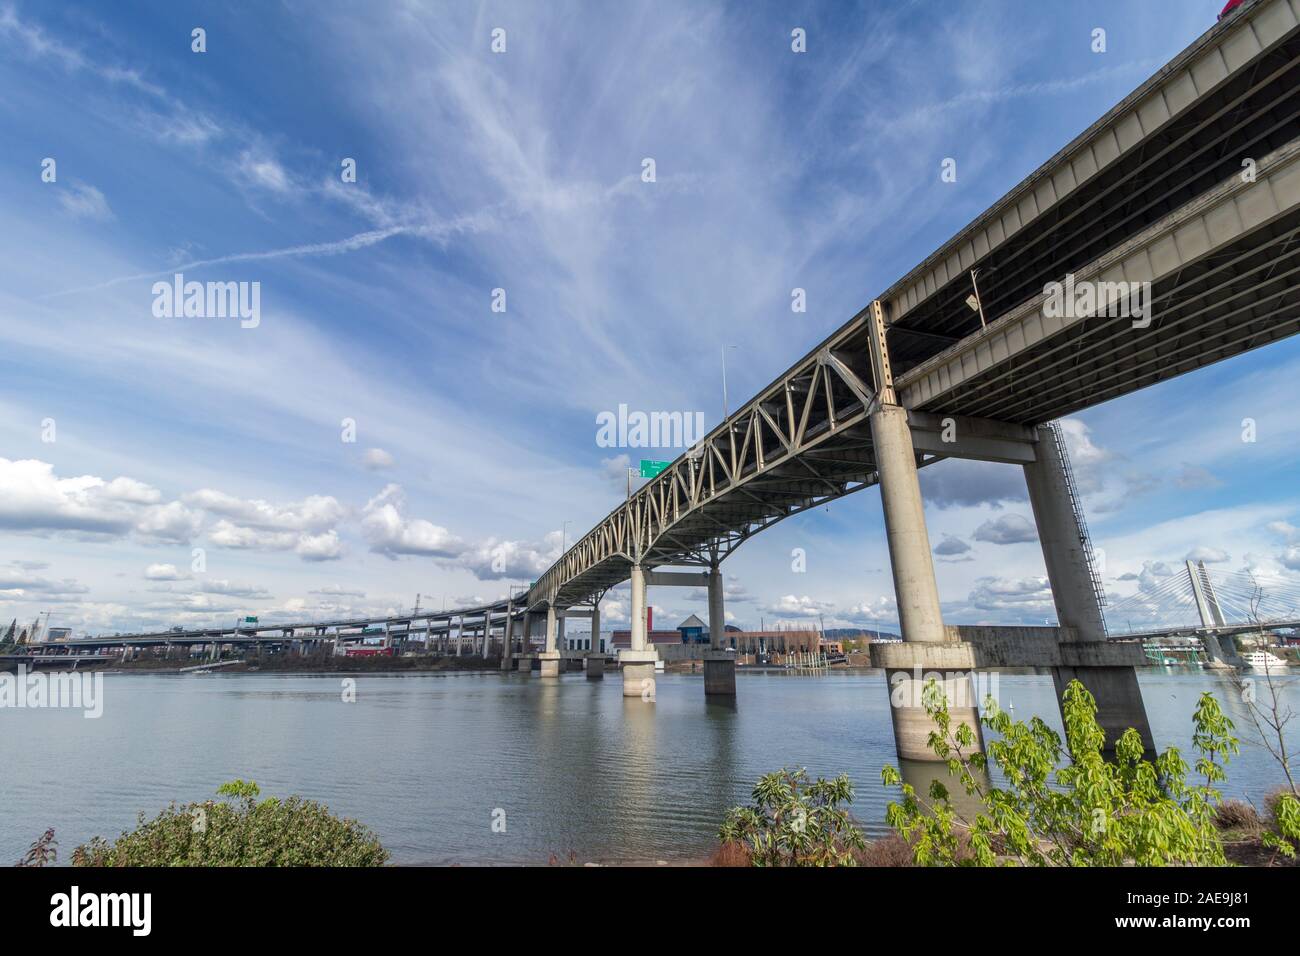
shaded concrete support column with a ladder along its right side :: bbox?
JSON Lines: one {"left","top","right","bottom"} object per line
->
{"left": 1024, "top": 425, "right": 1156, "bottom": 754}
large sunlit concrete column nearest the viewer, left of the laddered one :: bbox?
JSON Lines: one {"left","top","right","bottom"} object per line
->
{"left": 871, "top": 405, "right": 984, "bottom": 761}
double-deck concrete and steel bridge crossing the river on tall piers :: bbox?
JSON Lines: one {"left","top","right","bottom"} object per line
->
{"left": 32, "top": 0, "right": 1300, "bottom": 761}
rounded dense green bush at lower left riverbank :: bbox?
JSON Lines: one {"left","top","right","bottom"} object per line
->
{"left": 73, "top": 780, "right": 389, "bottom": 866}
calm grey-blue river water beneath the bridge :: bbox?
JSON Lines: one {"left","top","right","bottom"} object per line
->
{"left": 0, "top": 670, "right": 1300, "bottom": 864}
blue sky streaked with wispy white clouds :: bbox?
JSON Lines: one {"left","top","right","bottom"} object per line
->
{"left": 0, "top": 0, "right": 1300, "bottom": 632}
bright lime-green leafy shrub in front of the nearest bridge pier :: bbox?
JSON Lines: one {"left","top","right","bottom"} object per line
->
{"left": 883, "top": 680, "right": 1238, "bottom": 866}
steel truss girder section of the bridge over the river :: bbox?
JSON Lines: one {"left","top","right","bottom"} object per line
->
{"left": 529, "top": 313, "right": 875, "bottom": 606}
